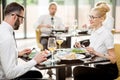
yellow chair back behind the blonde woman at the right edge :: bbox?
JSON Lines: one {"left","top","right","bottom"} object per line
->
{"left": 114, "top": 44, "right": 120, "bottom": 80}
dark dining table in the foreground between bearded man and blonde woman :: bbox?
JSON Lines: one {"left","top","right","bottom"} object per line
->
{"left": 21, "top": 48, "right": 110, "bottom": 80}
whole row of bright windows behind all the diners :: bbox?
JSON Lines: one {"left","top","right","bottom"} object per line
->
{"left": 0, "top": 0, "right": 120, "bottom": 38}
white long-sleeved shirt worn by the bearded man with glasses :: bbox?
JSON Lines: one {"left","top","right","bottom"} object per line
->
{"left": 0, "top": 22, "right": 36, "bottom": 80}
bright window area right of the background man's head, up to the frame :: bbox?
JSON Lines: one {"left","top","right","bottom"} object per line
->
{"left": 54, "top": 0, "right": 76, "bottom": 27}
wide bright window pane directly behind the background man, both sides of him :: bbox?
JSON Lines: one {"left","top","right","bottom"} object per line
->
{"left": 26, "top": 0, "right": 75, "bottom": 37}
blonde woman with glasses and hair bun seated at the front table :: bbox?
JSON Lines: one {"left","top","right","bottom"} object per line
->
{"left": 73, "top": 7, "right": 118, "bottom": 80}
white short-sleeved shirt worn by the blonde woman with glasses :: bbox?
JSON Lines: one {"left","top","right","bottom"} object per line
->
{"left": 90, "top": 26, "right": 114, "bottom": 54}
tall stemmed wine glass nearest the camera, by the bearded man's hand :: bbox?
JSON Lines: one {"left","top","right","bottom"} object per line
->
{"left": 47, "top": 38, "right": 57, "bottom": 65}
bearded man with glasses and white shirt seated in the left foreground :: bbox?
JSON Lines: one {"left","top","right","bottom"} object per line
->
{"left": 0, "top": 2, "right": 47, "bottom": 80}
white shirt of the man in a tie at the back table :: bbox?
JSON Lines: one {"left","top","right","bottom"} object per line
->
{"left": 34, "top": 15, "right": 65, "bottom": 36}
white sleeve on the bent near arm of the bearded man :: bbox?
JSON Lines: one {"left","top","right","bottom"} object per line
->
{"left": 0, "top": 37, "right": 37, "bottom": 79}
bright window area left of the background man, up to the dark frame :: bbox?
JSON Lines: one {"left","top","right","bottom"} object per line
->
{"left": 26, "top": 0, "right": 49, "bottom": 38}
